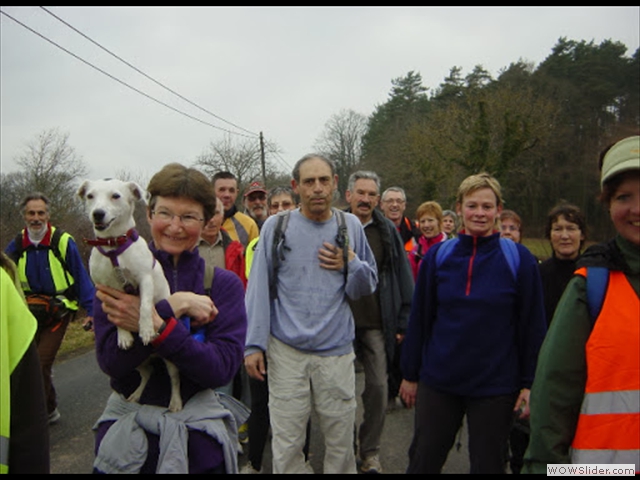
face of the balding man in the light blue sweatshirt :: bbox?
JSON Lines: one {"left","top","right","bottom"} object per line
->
{"left": 291, "top": 158, "right": 338, "bottom": 221}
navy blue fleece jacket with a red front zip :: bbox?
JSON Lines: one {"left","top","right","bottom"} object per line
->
{"left": 401, "top": 233, "right": 546, "bottom": 397}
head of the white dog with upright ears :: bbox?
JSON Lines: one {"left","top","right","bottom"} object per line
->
{"left": 77, "top": 178, "right": 147, "bottom": 237}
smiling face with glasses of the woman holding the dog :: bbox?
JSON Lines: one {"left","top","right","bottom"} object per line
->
{"left": 148, "top": 197, "right": 204, "bottom": 261}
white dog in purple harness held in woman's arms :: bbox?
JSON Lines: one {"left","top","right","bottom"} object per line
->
{"left": 77, "top": 179, "right": 182, "bottom": 411}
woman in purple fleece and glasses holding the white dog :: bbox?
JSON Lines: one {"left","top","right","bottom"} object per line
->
{"left": 94, "top": 163, "right": 247, "bottom": 473}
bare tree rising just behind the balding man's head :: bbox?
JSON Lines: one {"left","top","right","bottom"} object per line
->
{"left": 314, "top": 109, "right": 367, "bottom": 194}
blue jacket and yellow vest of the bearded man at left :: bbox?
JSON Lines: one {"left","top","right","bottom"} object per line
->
{"left": 5, "top": 224, "right": 95, "bottom": 315}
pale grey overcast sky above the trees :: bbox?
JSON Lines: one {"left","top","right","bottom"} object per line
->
{"left": 0, "top": 6, "right": 640, "bottom": 179}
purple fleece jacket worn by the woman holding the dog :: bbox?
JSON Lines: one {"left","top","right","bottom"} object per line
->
{"left": 93, "top": 242, "right": 247, "bottom": 473}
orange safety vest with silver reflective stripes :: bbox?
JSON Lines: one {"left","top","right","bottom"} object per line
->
{"left": 571, "top": 268, "right": 640, "bottom": 473}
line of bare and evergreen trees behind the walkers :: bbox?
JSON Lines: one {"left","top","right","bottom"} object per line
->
{"left": 0, "top": 38, "right": 640, "bottom": 254}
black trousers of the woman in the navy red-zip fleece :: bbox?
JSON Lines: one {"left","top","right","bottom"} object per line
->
{"left": 407, "top": 382, "right": 518, "bottom": 474}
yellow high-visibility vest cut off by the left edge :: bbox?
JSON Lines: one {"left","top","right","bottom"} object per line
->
{"left": 0, "top": 268, "right": 38, "bottom": 473}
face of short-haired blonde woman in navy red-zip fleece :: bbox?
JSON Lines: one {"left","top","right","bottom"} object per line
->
{"left": 457, "top": 188, "right": 502, "bottom": 237}
